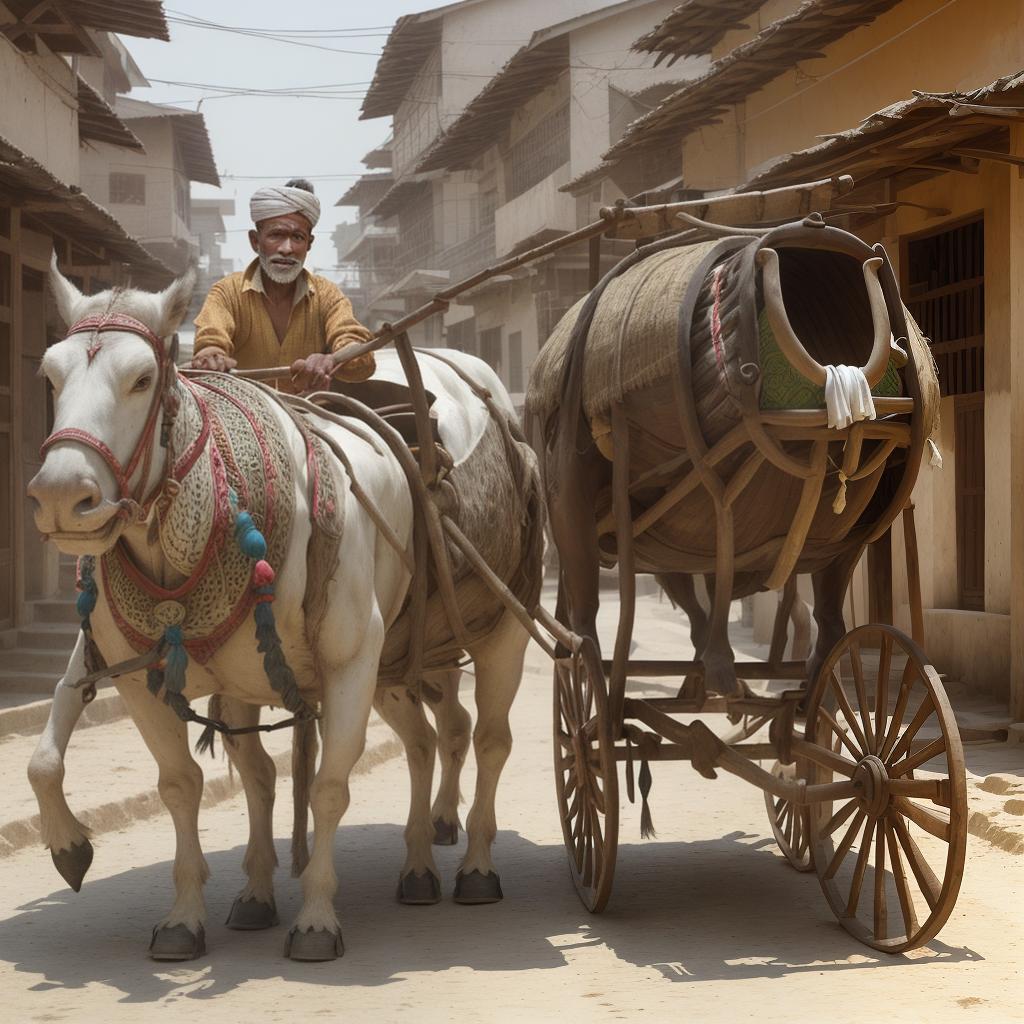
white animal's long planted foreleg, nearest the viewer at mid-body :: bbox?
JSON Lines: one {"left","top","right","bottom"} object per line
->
{"left": 285, "top": 614, "right": 384, "bottom": 961}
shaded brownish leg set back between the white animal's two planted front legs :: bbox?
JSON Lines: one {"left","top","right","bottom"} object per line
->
{"left": 217, "top": 696, "right": 278, "bottom": 932}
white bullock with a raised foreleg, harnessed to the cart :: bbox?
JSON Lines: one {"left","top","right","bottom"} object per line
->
{"left": 29, "top": 265, "right": 532, "bottom": 959}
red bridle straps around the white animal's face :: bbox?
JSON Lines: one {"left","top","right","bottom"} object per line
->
{"left": 39, "top": 312, "right": 174, "bottom": 507}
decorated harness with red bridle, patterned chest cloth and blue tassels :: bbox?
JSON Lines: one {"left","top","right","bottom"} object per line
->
{"left": 42, "top": 313, "right": 331, "bottom": 746}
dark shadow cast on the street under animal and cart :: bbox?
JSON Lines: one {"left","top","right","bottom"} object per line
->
{"left": 0, "top": 825, "right": 982, "bottom": 1004}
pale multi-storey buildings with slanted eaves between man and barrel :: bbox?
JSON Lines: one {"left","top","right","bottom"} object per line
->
{"left": 358, "top": 0, "right": 707, "bottom": 398}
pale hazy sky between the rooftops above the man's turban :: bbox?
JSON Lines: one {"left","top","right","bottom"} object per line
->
{"left": 122, "top": 0, "right": 464, "bottom": 276}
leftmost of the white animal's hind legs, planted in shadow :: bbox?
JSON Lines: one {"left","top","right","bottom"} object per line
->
{"left": 374, "top": 688, "right": 441, "bottom": 906}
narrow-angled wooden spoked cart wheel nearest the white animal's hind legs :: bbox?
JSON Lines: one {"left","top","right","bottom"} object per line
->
{"left": 554, "top": 637, "right": 618, "bottom": 913}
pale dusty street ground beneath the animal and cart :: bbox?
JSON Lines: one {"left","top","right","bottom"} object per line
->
{"left": 0, "top": 593, "right": 1024, "bottom": 1024}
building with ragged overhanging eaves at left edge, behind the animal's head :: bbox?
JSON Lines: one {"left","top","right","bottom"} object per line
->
{"left": 0, "top": 0, "right": 215, "bottom": 702}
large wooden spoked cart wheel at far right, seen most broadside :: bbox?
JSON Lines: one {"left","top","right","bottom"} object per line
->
{"left": 801, "top": 626, "right": 967, "bottom": 953}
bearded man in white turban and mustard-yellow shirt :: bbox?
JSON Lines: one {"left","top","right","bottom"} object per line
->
{"left": 191, "top": 178, "right": 375, "bottom": 392}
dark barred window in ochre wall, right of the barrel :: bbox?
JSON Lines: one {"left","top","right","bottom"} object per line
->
{"left": 904, "top": 219, "right": 985, "bottom": 395}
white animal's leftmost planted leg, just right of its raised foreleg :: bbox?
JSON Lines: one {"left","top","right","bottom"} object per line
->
{"left": 117, "top": 676, "right": 210, "bottom": 961}
